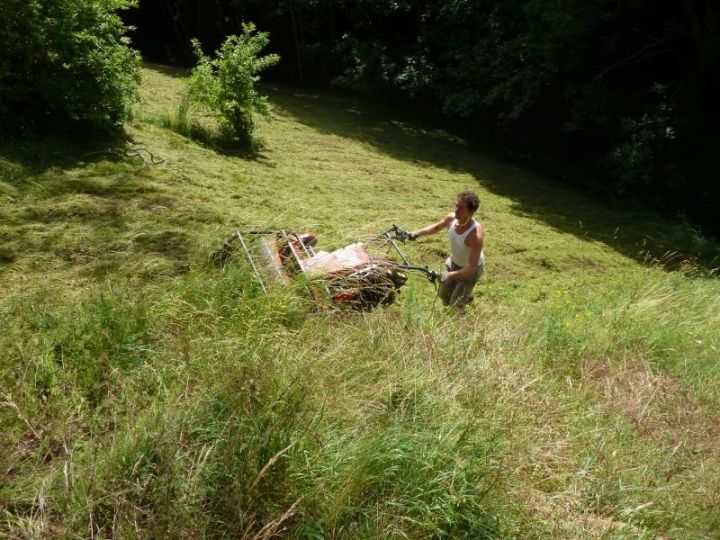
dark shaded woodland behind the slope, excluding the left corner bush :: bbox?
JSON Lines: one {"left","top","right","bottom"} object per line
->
{"left": 128, "top": 0, "right": 720, "bottom": 231}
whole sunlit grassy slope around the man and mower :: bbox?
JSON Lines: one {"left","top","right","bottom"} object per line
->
{"left": 0, "top": 68, "right": 720, "bottom": 538}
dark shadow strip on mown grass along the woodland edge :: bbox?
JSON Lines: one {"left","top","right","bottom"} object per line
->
{"left": 263, "top": 85, "right": 720, "bottom": 272}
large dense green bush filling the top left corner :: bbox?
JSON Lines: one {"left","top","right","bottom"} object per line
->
{"left": 0, "top": 0, "right": 140, "bottom": 135}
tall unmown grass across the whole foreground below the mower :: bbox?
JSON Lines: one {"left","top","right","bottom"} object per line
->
{"left": 2, "top": 247, "right": 717, "bottom": 538}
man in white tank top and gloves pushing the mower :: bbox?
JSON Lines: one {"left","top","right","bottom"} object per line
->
{"left": 409, "top": 191, "right": 485, "bottom": 307}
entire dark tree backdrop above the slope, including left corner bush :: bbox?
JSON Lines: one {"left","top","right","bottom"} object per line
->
{"left": 0, "top": 0, "right": 720, "bottom": 234}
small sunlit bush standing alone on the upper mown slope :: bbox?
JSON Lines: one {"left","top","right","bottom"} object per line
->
{"left": 188, "top": 23, "right": 280, "bottom": 143}
